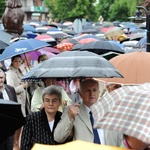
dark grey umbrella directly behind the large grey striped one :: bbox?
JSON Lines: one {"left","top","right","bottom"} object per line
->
{"left": 72, "top": 41, "right": 124, "bottom": 54}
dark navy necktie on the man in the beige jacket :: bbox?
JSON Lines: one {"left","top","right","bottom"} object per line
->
{"left": 89, "top": 111, "right": 100, "bottom": 144}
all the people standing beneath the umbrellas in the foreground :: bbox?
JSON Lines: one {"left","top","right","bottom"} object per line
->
{"left": 0, "top": 51, "right": 149, "bottom": 150}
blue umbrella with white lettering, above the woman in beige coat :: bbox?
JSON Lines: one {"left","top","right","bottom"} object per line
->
{"left": 0, "top": 39, "right": 50, "bottom": 61}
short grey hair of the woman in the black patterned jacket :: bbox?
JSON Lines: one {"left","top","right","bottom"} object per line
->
{"left": 42, "top": 85, "right": 62, "bottom": 102}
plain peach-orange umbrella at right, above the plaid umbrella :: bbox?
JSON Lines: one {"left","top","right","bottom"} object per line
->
{"left": 99, "top": 51, "right": 150, "bottom": 84}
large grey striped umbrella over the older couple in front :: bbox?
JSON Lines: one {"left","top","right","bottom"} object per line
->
{"left": 22, "top": 51, "right": 122, "bottom": 79}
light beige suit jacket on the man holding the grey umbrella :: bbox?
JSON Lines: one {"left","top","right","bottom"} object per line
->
{"left": 54, "top": 104, "right": 122, "bottom": 146}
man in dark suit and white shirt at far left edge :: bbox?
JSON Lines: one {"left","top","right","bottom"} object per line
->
{"left": 0, "top": 69, "right": 17, "bottom": 150}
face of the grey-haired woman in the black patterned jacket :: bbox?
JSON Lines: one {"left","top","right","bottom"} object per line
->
{"left": 43, "top": 94, "right": 61, "bottom": 114}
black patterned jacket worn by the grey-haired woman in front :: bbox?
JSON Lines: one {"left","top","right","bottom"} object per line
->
{"left": 21, "top": 108, "right": 62, "bottom": 150}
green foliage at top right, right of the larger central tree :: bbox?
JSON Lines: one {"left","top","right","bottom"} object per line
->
{"left": 96, "top": 0, "right": 145, "bottom": 21}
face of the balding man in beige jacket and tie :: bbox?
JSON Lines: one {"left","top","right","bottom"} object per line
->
{"left": 80, "top": 81, "right": 99, "bottom": 107}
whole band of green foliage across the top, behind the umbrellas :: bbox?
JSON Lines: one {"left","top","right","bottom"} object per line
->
{"left": 45, "top": 0, "right": 149, "bottom": 21}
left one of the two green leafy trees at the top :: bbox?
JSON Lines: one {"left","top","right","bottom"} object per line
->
{"left": 45, "top": 0, "right": 98, "bottom": 21}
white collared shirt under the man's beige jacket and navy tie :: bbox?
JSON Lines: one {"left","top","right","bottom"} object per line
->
{"left": 85, "top": 105, "right": 105, "bottom": 145}
